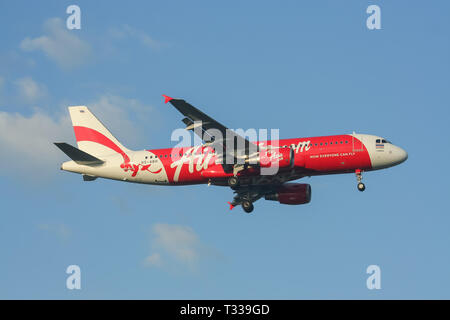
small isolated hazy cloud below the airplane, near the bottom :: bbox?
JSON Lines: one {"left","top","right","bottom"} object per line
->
{"left": 145, "top": 223, "right": 203, "bottom": 269}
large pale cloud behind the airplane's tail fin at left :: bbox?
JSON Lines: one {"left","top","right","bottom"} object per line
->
{"left": 0, "top": 95, "right": 154, "bottom": 181}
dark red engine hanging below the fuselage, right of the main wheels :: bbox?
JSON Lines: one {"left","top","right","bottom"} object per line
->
{"left": 265, "top": 183, "right": 311, "bottom": 204}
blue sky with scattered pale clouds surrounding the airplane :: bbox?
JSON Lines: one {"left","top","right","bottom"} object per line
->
{"left": 0, "top": 0, "right": 450, "bottom": 299}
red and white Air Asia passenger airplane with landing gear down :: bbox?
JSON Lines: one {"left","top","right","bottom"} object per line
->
{"left": 55, "top": 95, "right": 408, "bottom": 213}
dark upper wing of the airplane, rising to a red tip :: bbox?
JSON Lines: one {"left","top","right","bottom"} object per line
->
{"left": 163, "top": 95, "right": 258, "bottom": 160}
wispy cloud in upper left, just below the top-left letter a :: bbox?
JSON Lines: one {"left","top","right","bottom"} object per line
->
{"left": 20, "top": 18, "right": 91, "bottom": 69}
